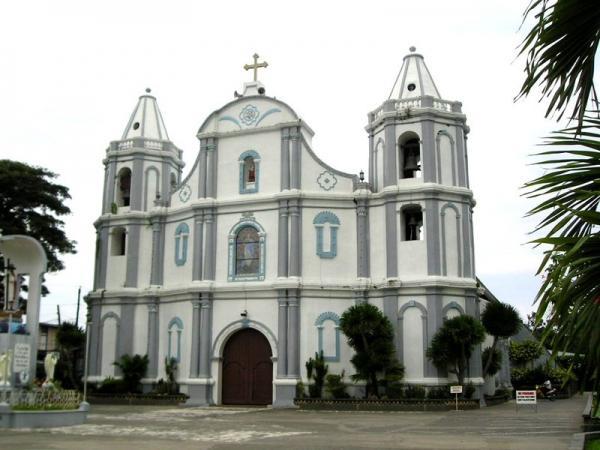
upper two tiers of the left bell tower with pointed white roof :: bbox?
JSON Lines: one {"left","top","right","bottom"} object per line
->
{"left": 94, "top": 89, "right": 184, "bottom": 289}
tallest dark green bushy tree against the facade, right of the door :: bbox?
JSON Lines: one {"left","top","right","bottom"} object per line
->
{"left": 340, "top": 303, "right": 404, "bottom": 396}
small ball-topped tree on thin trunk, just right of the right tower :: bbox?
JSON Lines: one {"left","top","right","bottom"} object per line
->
{"left": 481, "top": 302, "right": 521, "bottom": 376}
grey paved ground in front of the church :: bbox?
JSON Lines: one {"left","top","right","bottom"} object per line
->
{"left": 0, "top": 396, "right": 585, "bottom": 450}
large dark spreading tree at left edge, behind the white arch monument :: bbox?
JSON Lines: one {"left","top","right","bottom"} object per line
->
{"left": 0, "top": 159, "right": 75, "bottom": 295}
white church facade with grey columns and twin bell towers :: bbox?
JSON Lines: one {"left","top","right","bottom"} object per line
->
{"left": 87, "top": 49, "right": 496, "bottom": 406}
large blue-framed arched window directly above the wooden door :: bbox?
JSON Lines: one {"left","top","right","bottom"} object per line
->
{"left": 229, "top": 219, "right": 265, "bottom": 281}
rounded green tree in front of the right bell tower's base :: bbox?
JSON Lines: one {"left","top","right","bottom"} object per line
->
{"left": 427, "top": 315, "right": 485, "bottom": 385}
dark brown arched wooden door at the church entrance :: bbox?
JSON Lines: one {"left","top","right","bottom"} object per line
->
{"left": 222, "top": 328, "right": 273, "bottom": 405}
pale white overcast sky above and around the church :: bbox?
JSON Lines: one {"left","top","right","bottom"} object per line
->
{"left": 0, "top": 0, "right": 558, "bottom": 322}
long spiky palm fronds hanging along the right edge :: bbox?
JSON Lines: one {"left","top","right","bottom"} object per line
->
{"left": 518, "top": 0, "right": 600, "bottom": 406}
